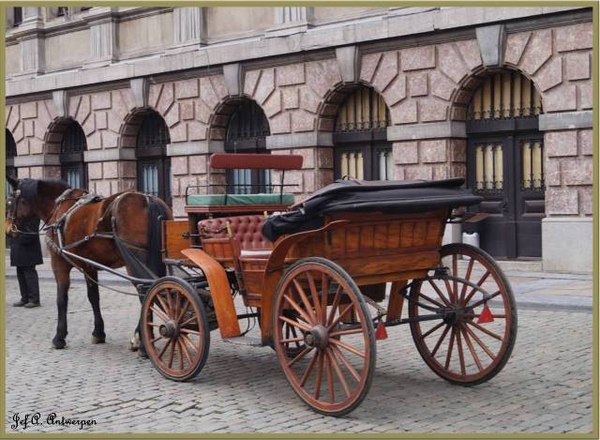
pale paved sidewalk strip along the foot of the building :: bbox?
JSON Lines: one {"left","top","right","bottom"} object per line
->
{"left": 5, "top": 257, "right": 593, "bottom": 309}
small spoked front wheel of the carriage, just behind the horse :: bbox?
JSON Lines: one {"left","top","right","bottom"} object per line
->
{"left": 142, "top": 277, "right": 210, "bottom": 381}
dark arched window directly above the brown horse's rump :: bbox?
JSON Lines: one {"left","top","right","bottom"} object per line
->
{"left": 135, "top": 111, "right": 171, "bottom": 205}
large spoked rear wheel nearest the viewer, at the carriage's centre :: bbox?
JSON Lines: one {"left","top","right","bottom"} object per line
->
{"left": 274, "top": 257, "right": 376, "bottom": 416}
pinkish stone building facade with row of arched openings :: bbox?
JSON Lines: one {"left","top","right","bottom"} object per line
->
{"left": 5, "top": 5, "right": 597, "bottom": 273}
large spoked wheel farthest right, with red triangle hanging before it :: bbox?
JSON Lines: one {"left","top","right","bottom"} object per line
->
{"left": 409, "top": 243, "right": 517, "bottom": 386}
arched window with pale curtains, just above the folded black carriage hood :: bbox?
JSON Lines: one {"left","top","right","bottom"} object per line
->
{"left": 333, "top": 87, "right": 394, "bottom": 180}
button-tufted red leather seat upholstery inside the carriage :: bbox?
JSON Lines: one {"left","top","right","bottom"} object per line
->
{"left": 198, "top": 214, "right": 273, "bottom": 252}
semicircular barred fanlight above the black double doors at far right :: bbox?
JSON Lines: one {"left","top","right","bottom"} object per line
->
{"left": 467, "top": 72, "right": 542, "bottom": 120}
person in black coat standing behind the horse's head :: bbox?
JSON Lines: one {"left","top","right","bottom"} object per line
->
{"left": 10, "top": 219, "right": 43, "bottom": 309}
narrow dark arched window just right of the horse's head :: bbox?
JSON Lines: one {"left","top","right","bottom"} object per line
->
{"left": 60, "top": 121, "right": 88, "bottom": 189}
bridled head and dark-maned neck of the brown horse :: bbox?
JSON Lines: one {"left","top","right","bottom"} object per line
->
{"left": 4, "top": 176, "right": 69, "bottom": 237}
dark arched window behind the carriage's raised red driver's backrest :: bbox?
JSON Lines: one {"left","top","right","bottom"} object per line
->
{"left": 225, "top": 101, "right": 271, "bottom": 194}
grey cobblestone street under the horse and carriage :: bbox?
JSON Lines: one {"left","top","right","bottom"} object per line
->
{"left": 5, "top": 277, "right": 593, "bottom": 434}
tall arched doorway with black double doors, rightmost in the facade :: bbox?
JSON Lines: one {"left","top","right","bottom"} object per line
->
{"left": 466, "top": 71, "right": 545, "bottom": 259}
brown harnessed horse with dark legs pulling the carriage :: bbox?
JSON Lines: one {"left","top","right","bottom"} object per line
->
{"left": 5, "top": 176, "right": 173, "bottom": 348}
